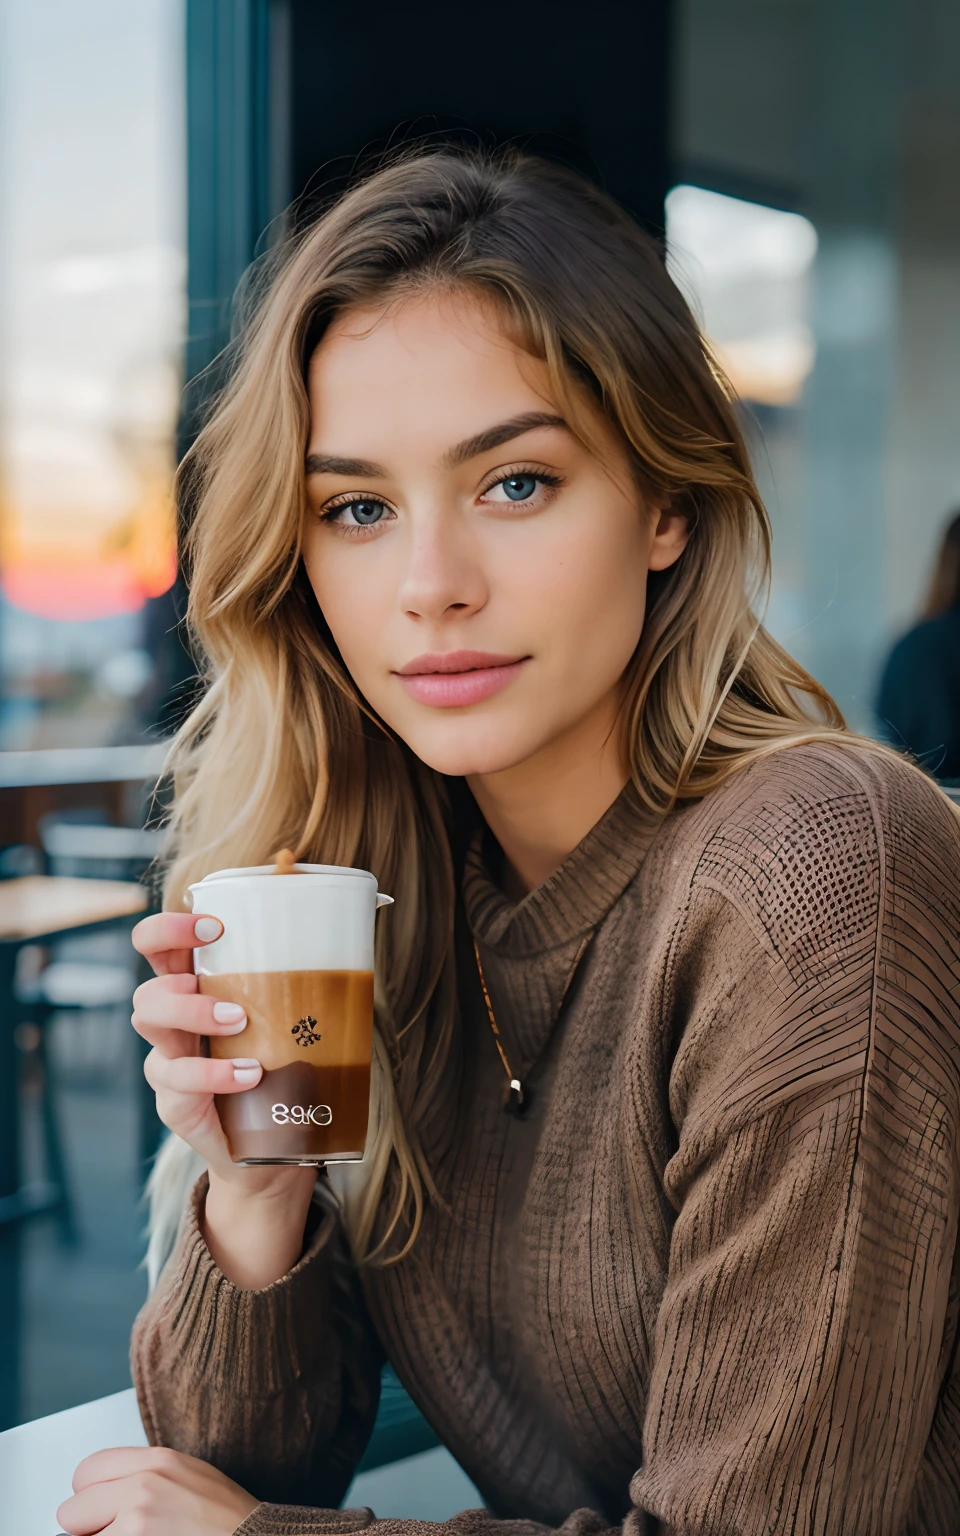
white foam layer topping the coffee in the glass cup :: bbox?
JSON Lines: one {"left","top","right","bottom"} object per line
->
{"left": 189, "top": 863, "right": 392, "bottom": 975}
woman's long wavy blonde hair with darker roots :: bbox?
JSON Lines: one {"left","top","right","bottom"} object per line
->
{"left": 154, "top": 149, "right": 860, "bottom": 1263}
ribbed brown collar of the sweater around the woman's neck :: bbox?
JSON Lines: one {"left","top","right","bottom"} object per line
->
{"left": 462, "top": 783, "right": 660, "bottom": 958}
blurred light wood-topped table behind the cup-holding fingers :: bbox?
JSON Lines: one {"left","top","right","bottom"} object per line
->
{"left": 0, "top": 876, "right": 149, "bottom": 1430}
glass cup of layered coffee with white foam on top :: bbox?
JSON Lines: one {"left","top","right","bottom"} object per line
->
{"left": 189, "top": 862, "right": 393, "bottom": 1164}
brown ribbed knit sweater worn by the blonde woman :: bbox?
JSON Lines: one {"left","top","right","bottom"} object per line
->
{"left": 134, "top": 746, "right": 960, "bottom": 1536}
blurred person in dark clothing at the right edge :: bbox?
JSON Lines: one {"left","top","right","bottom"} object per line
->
{"left": 877, "top": 511, "right": 960, "bottom": 782}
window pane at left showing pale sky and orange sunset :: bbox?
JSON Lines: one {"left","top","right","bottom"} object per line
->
{"left": 0, "top": 0, "right": 184, "bottom": 748}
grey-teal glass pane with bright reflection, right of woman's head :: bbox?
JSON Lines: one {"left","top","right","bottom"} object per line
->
{"left": 670, "top": 0, "right": 960, "bottom": 749}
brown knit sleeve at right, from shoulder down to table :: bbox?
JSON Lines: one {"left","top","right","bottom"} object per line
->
{"left": 238, "top": 756, "right": 960, "bottom": 1536}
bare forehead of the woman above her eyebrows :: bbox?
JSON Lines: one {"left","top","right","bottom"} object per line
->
{"left": 302, "top": 293, "right": 556, "bottom": 453}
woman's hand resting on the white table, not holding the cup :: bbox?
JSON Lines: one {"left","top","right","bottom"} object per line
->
{"left": 57, "top": 1447, "right": 260, "bottom": 1536}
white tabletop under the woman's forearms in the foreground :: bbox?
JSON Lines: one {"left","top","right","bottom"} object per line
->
{"left": 0, "top": 1390, "right": 484, "bottom": 1536}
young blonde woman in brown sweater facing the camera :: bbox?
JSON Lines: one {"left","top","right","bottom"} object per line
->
{"left": 60, "top": 152, "right": 960, "bottom": 1536}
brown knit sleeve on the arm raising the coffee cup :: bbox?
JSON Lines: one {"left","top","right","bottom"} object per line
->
{"left": 131, "top": 1175, "right": 382, "bottom": 1504}
